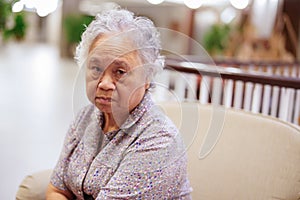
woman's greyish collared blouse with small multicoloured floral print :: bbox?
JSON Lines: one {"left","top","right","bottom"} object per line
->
{"left": 51, "top": 92, "right": 191, "bottom": 200}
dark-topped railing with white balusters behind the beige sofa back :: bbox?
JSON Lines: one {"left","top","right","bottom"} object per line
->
{"left": 156, "top": 59, "right": 300, "bottom": 125}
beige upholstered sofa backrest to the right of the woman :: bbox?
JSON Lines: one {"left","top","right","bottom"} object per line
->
{"left": 160, "top": 103, "right": 300, "bottom": 200}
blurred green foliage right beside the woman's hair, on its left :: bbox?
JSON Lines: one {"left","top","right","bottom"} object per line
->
{"left": 63, "top": 14, "right": 93, "bottom": 44}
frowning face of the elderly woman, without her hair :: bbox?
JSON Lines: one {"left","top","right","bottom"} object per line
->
{"left": 86, "top": 36, "right": 149, "bottom": 117}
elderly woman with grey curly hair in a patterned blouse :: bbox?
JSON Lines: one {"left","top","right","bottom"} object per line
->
{"left": 46, "top": 9, "right": 191, "bottom": 200}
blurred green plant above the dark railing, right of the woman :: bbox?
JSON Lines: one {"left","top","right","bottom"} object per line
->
{"left": 203, "top": 24, "right": 230, "bottom": 54}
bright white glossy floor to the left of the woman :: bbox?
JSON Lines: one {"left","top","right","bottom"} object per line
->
{"left": 0, "top": 43, "right": 85, "bottom": 200}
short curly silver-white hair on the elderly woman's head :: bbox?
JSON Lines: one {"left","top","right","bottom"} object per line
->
{"left": 75, "top": 7, "right": 164, "bottom": 80}
